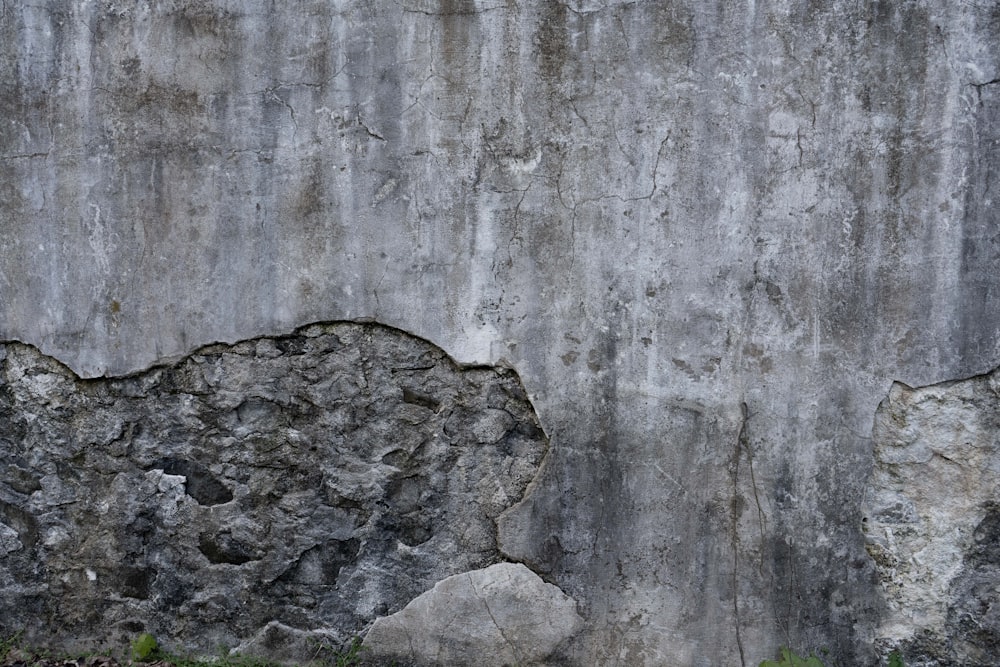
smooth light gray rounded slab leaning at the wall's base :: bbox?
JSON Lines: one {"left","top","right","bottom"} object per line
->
{"left": 364, "top": 563, "right": 583, "bottom": 667}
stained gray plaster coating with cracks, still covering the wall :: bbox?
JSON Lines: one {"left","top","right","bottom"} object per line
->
{"left": 0, "top": 0, "right": 1000, "bottom": 665}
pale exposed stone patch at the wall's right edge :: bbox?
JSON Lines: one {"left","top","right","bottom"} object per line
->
{"left": 863, "top": 371, "right": 1000, "bottom": 667}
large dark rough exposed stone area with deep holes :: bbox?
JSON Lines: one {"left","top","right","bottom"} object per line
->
{"left": 0, "top": 323, "right": 547, "bottom": 659}
